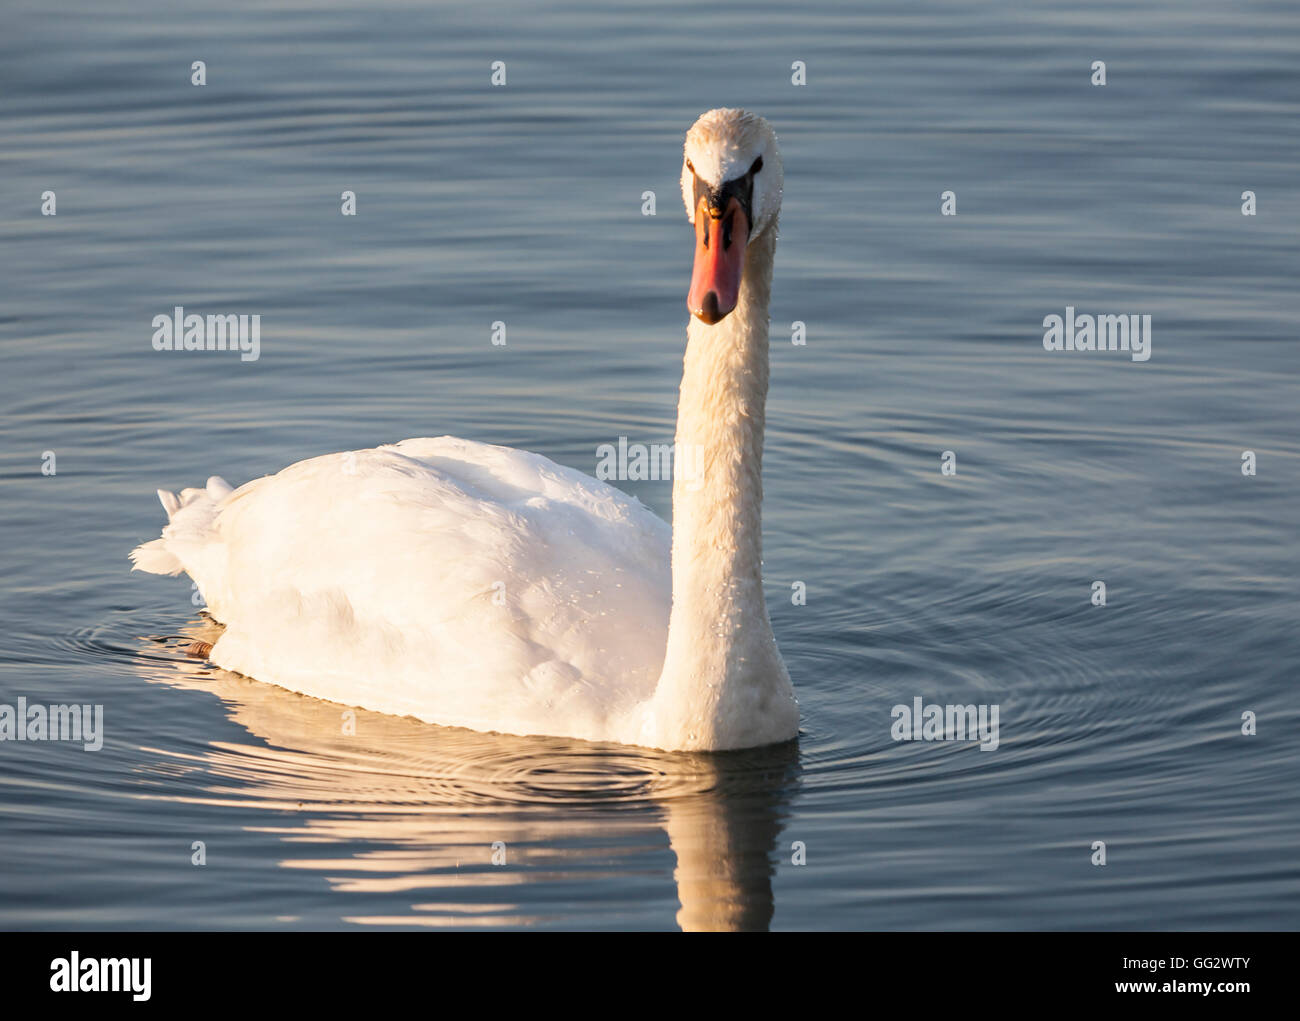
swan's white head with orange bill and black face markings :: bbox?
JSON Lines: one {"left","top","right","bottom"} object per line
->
{"left": 681, "top": 109, "right": 783, "bottom": 325}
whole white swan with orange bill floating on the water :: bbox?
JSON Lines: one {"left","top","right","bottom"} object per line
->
{"left": 131, "top": 109, "right": 800, "bottom": 752}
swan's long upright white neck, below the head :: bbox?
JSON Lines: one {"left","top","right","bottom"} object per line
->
{"left": 651, "top": 222, "right": 798, "bottom": 749}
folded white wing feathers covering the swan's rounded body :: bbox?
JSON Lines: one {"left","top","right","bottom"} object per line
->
{"left": 176, "top": 437, "right": 671, "bottom": 740}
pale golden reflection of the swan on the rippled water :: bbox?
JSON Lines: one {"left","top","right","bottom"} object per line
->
{"left": 139, "top": 622, "right": 800, "bottom": 930}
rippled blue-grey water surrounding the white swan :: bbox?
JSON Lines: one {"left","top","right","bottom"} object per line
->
{"left": 0, "top": 0, "right": 1300, "bottom": 929}
